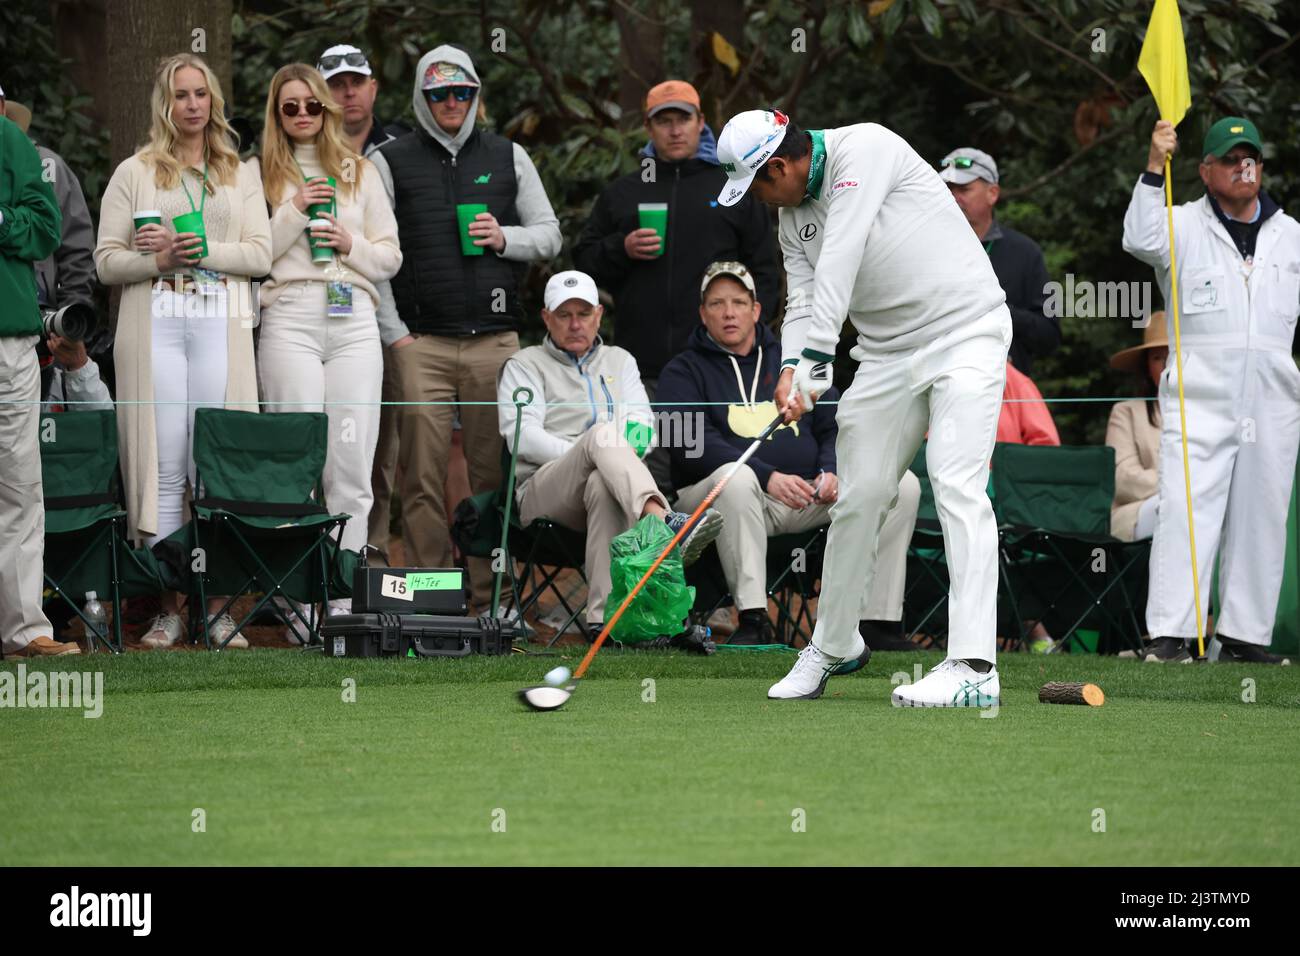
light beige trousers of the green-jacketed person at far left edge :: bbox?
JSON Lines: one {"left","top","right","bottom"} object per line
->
{"left": 0, "top": 336, "right": 57, "bottom": 653}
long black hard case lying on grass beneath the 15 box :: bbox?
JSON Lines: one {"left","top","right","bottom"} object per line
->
{"left": 321, "top": 614, "right": 523, "bottom": 657}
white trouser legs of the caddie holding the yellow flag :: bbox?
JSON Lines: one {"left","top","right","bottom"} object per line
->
{"left": 1147, "top": 343, "right": 1300, "bottom": 646}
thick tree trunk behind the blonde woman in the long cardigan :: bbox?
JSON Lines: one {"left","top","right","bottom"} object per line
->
{"left": 107, "top": 0, "right": 231, "bottom": 168}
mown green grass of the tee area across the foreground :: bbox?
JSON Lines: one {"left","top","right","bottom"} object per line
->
{"left": 0, "top": 650, "right": 1300, "bottom": 865}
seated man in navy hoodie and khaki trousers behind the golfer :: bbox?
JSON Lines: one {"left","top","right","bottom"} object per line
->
{"left": 657, "top": 263, "right": 920, "bottom": 650}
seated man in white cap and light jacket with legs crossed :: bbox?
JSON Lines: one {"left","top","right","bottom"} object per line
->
{"left": 497, "top": 272, "right": 722, "bottom": 636}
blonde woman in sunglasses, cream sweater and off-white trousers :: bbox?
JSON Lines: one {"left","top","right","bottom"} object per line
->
{"left": 257, "top": 64, "right": 402, "bottom": 621}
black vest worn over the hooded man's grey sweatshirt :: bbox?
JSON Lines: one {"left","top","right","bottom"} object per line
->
{"left": 381, "top": 130, "right": 525, "bottom": 336}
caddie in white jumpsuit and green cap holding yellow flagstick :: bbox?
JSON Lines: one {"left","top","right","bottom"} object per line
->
{"left": 1125, "top": 117, "right": 1300, "bottom": 663}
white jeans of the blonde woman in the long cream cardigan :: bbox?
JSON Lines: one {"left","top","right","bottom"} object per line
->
{"left": 148, "top": 290, "right": 229, "bottom": 545}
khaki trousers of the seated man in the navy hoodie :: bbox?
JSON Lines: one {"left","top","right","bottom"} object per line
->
{"left": 677, "top": 464, "right": 920, "bottom": 620}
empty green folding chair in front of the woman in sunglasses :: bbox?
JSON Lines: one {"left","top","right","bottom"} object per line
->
{"left": 178, "top": 408, "right": 356, "bottom": 650}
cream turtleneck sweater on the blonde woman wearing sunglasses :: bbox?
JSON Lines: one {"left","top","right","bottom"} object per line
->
{"left": 260, "top": 144, "right": 402, "bottom": 307}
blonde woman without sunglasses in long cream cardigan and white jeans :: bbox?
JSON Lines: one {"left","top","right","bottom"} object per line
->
{"left": 95, "top": 53, "right": 270, "bottom": 648}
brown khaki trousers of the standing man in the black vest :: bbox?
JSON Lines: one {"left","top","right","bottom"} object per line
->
{"left": 393, "top": 332, "right": 519, "bottom": 606}
